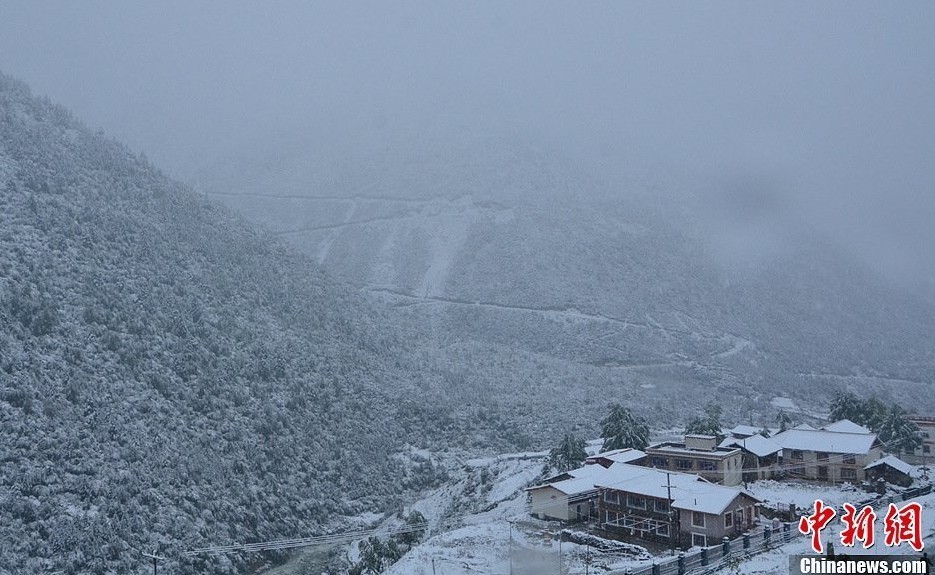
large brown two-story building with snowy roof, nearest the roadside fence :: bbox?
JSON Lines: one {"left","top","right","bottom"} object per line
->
{"left": 596, "top": 465, "right": 760, "bottom": 547}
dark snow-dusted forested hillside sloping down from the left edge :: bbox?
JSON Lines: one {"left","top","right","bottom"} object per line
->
{"left": 0, "top": 76, "right": 497, "bottom": 574}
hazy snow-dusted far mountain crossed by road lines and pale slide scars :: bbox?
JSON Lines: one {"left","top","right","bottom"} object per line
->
{"left": 199, "top": 133, "right": 935, "bottom": 414}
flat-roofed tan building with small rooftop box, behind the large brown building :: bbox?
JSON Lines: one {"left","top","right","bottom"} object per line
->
{"left": 644, "top": 435, "right": 743, "bottom": 485}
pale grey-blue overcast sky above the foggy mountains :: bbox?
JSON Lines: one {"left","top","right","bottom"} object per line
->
{"left": 0, "top": 0, "right": 935, "bottom": 292}
